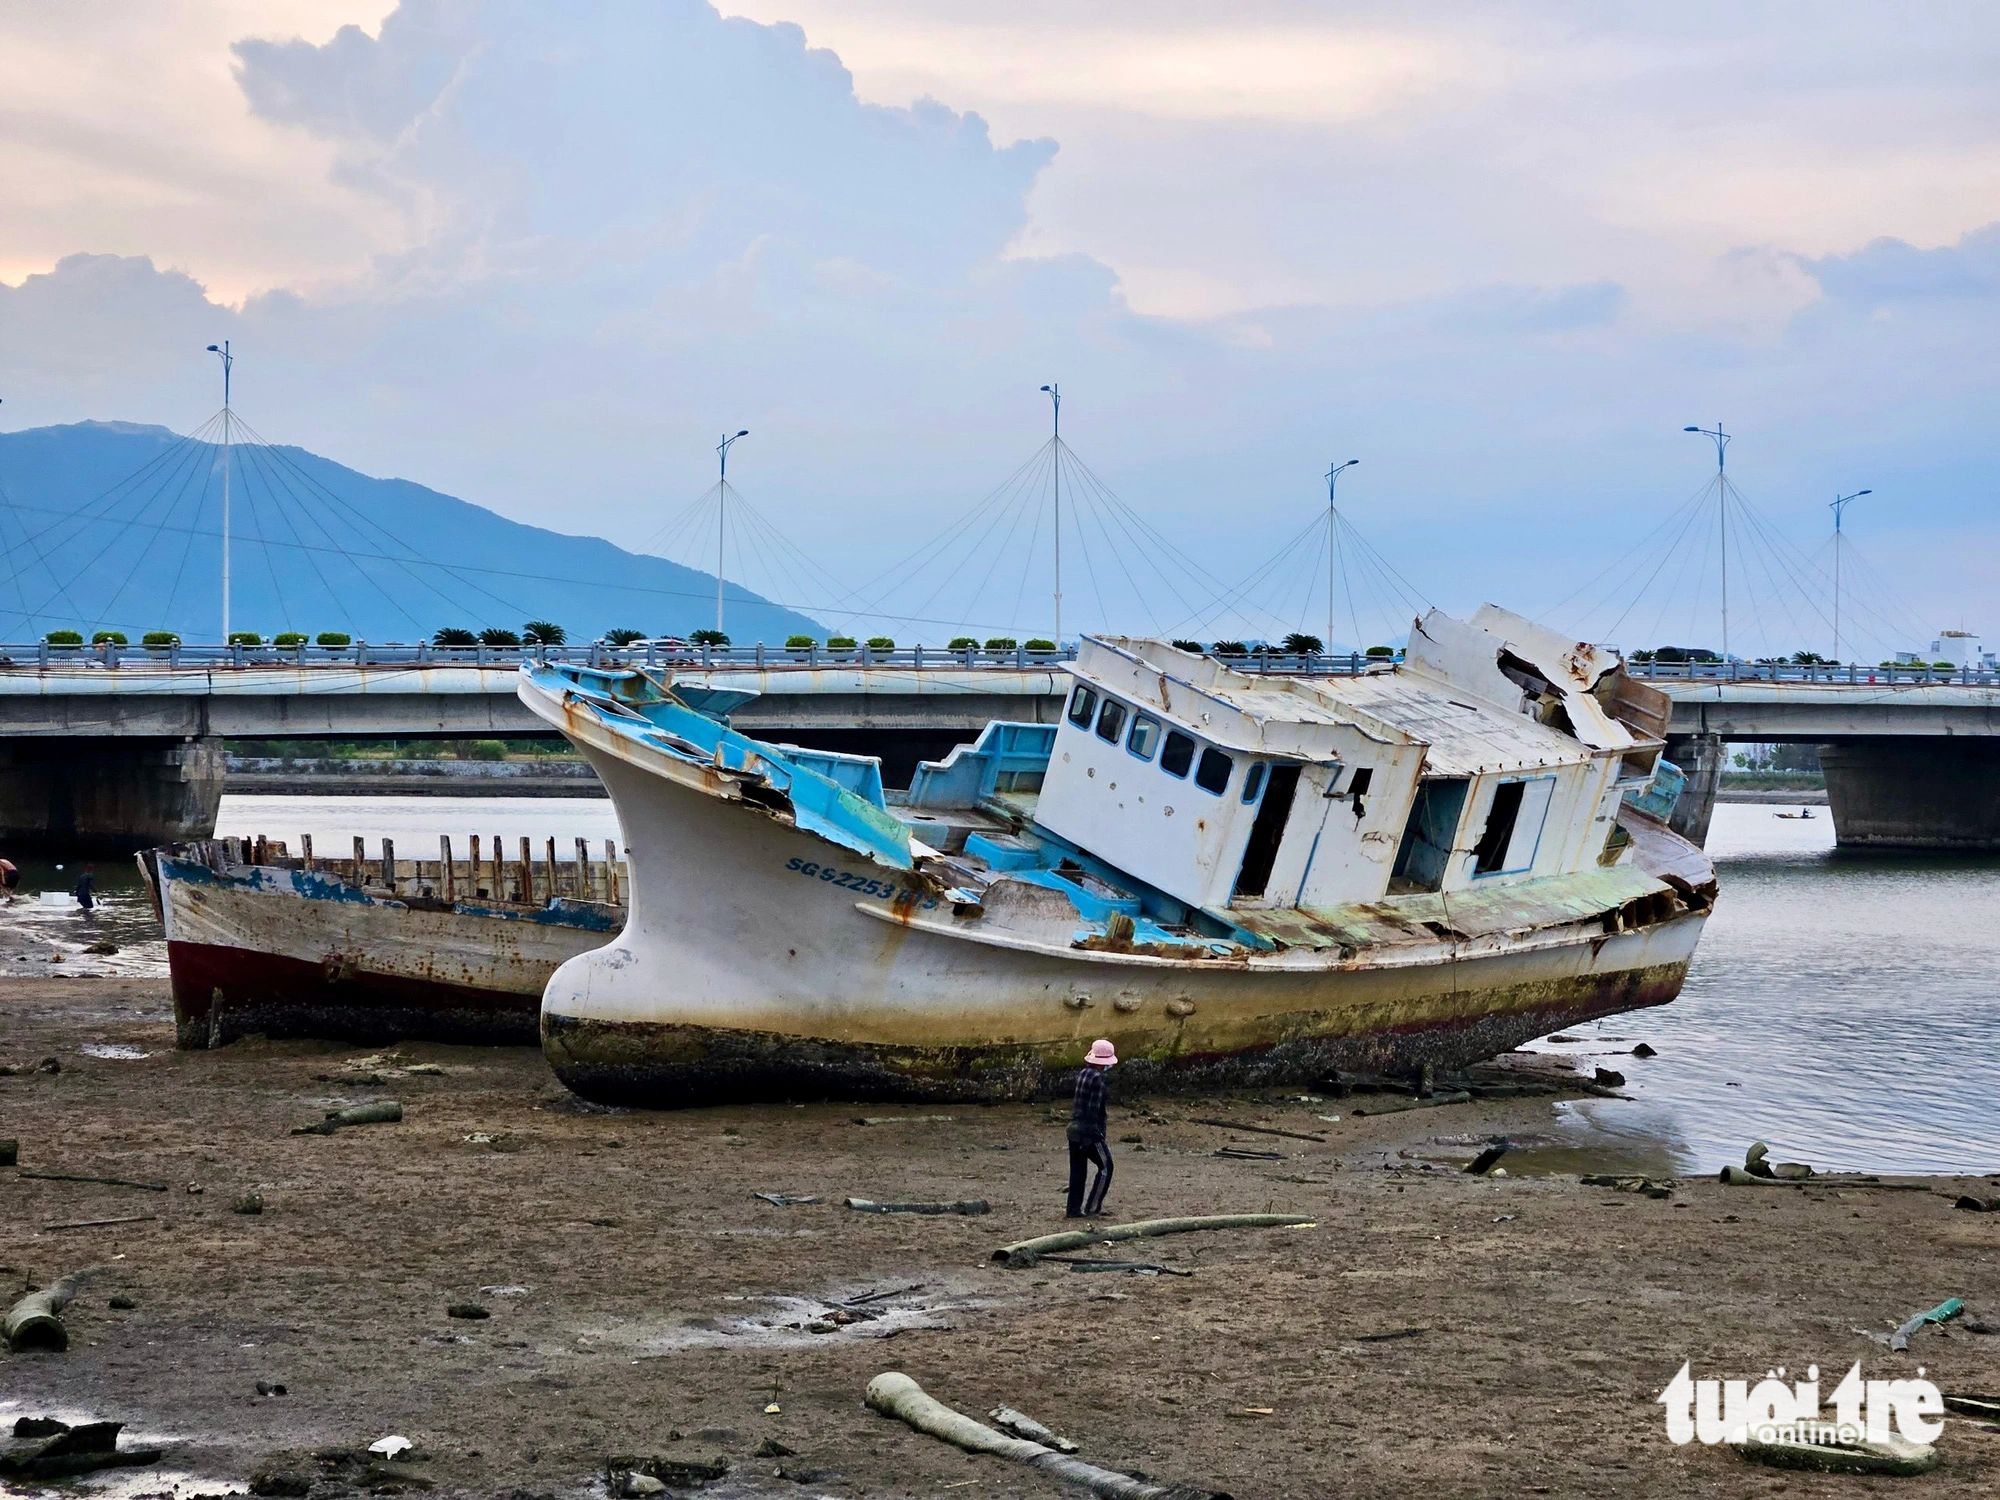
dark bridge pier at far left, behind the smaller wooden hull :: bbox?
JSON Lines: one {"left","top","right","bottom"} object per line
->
{"left": 0, "top": 736, "right": 224, "bottom": 854}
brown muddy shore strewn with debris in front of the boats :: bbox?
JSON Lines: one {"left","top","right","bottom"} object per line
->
{"left": 0, "top": 978, "right": 2000, "bottom": 1500}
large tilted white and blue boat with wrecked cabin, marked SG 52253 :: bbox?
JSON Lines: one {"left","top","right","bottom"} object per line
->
{"left": 520, "top": 606, "right": 1716, "bottom": 1106}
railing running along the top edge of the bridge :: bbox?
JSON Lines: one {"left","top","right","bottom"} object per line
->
{"left": 0, "top": 640, "right": 2000, "bottom": 686}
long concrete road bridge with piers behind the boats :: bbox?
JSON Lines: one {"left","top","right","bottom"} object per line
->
{"left": 0, "top": 646, "right": 2000, "bottom": 850}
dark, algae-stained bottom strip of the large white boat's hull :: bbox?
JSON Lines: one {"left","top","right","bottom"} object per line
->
{"left": 542, "top": 962, "right": 1688, "bottom": 1108}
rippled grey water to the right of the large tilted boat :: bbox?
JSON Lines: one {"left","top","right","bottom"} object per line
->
{"left": 1542, "top": 806, "right": 2000, "bottom": 1172}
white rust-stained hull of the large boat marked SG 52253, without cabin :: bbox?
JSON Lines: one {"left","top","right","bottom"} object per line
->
{"left": 522, "top": 664, "right": 1714, "bottom": 1108}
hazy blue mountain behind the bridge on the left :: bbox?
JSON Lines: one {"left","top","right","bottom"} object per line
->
{"left": 0, "top": 422, "right": 824, "bottom": 644}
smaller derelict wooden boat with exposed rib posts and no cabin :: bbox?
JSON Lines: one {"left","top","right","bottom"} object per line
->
{"left": 138, "top": 836, "right": 624, "bottom": 1048}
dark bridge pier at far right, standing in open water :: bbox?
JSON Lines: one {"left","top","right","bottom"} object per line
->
{"left": 1820, "top": 736, "right": 2000, "bottom": 854}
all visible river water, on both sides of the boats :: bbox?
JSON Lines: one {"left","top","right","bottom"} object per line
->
{"left": 19, "top": 796, "right": 2000, "bottom": 1174}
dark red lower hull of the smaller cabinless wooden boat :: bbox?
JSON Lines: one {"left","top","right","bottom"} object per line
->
{"left": 166, "top": 942, "right": 542, "bottom": 1048}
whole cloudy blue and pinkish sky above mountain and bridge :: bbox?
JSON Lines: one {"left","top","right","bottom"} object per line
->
{"left": 0, "top": 0, "right": 2000, "bottom": 658}
